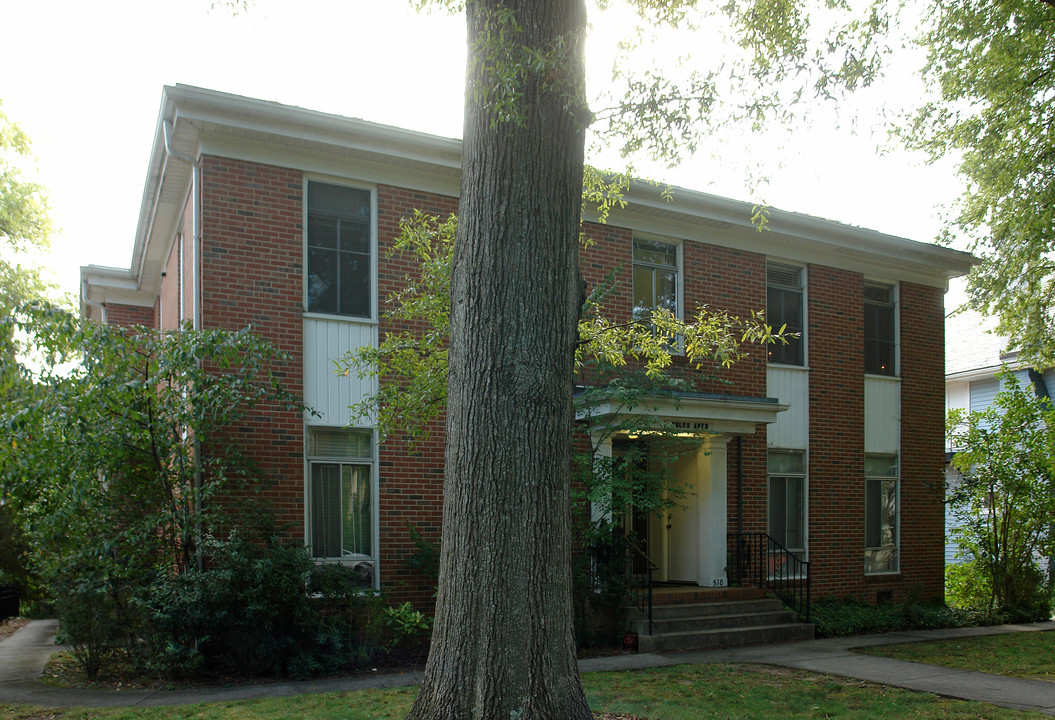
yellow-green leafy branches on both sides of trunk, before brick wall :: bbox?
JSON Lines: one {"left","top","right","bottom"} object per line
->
{"left": 346, "top": 211, "right": 786, "bottom": 442}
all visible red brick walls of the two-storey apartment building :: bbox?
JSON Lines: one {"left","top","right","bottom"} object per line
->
{"left": 183, "top": 156, "right": 944, "bottom": 606}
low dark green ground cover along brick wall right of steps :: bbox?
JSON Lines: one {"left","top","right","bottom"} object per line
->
{"left": 809, "top": 598, "right": 977, "bottom": 638}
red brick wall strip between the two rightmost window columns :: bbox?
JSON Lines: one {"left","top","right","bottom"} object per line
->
{"left": 806, "top": 265, "right": 864, "bottom": 595}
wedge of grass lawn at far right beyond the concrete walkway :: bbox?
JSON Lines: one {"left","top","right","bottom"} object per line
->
{"left": 857, "top": 630, "right": 1055, "bottom": 682}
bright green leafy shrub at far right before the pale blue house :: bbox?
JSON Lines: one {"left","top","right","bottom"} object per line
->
{"left": 947, "top": 371, "right": 1055, "bottom": 618}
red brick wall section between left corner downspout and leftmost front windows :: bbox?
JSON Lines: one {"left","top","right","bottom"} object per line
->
{"left": 202, "top": 155, "right": 304, "bottom": 538}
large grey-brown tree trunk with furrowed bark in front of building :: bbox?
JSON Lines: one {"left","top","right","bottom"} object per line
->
{"left": 409, "top": 0, "right": 591, "bottom": 720}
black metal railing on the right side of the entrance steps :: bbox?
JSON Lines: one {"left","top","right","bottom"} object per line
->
{"left": 728, "top": 532, "right": 810, "bottom": 622}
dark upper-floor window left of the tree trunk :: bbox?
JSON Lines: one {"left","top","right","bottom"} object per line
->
{"left": 307, "top": 183, "right": 373, "bottom": 318}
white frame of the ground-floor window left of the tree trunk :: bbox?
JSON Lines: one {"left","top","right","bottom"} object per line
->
{"left": 304, "top": 425, "right": 381, "bottom": 590}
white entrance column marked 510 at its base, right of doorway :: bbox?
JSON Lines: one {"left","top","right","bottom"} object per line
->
{"left": 697, "top": 436, "right": 730, "bottom": 587}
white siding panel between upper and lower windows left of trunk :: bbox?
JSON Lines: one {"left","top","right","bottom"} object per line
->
{"left": 304, "top": 318, "right": 378, "bottom": 425}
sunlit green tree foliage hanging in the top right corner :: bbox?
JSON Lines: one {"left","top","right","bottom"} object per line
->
{"left": 903, "top": 0, "right": 1055, "bottom": 367}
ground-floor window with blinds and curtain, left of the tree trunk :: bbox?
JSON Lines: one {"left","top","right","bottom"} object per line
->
{"left": 307, "top": 428, "right": 377, "bottom": 584}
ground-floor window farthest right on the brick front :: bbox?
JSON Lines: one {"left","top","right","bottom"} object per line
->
{"left": 864, "top": 455, "right": 899, "bottom": 574}
